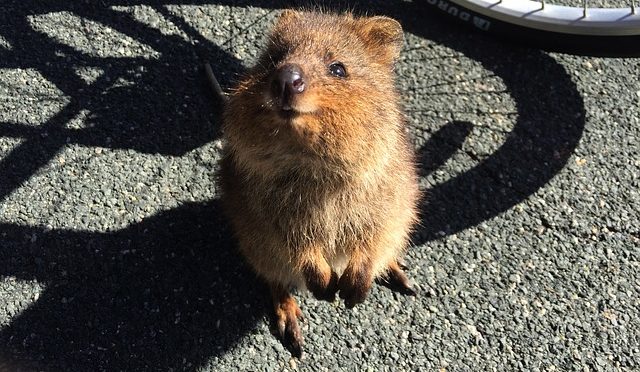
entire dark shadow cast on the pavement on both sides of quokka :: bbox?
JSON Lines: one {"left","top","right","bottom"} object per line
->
{"left": 0, "top": 0, "right": 584, "bottom": 370}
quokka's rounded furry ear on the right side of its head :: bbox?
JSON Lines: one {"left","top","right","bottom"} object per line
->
{"left": 358, "top": 16, "right": 404, "bottom": 64}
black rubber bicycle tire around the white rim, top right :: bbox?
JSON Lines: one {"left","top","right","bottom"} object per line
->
{"left": 418, "top": 0, "right": 640, "bottom": 57}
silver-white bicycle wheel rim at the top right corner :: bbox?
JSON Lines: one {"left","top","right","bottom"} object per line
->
{"left": 448, "top": 0, "right": 640, "bottom": 35}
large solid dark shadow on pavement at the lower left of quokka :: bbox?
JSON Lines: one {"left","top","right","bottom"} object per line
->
{"left": 0, "top": 202, "right": 269, "bottom": 371}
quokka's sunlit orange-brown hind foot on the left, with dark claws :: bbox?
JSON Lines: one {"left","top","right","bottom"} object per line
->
{"left": 270, "top": 284, "right": 303, "bottom": 358}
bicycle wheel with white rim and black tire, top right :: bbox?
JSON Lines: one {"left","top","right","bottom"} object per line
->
{"left": 426, "top": 0, "right": 640, "bottom": 57}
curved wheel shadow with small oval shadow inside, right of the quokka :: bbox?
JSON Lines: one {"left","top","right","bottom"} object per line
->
{"left": 398, "top": 2, "right": 585, "bottom": 241}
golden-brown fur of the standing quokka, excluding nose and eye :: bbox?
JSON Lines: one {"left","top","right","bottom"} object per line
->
{"left": 221, "top": 11, "right": 419, "bottom": 354}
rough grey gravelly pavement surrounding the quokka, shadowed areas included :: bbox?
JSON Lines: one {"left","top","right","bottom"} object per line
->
{"left": 0, "top": 0, "right": 640, "bottom": 371}
